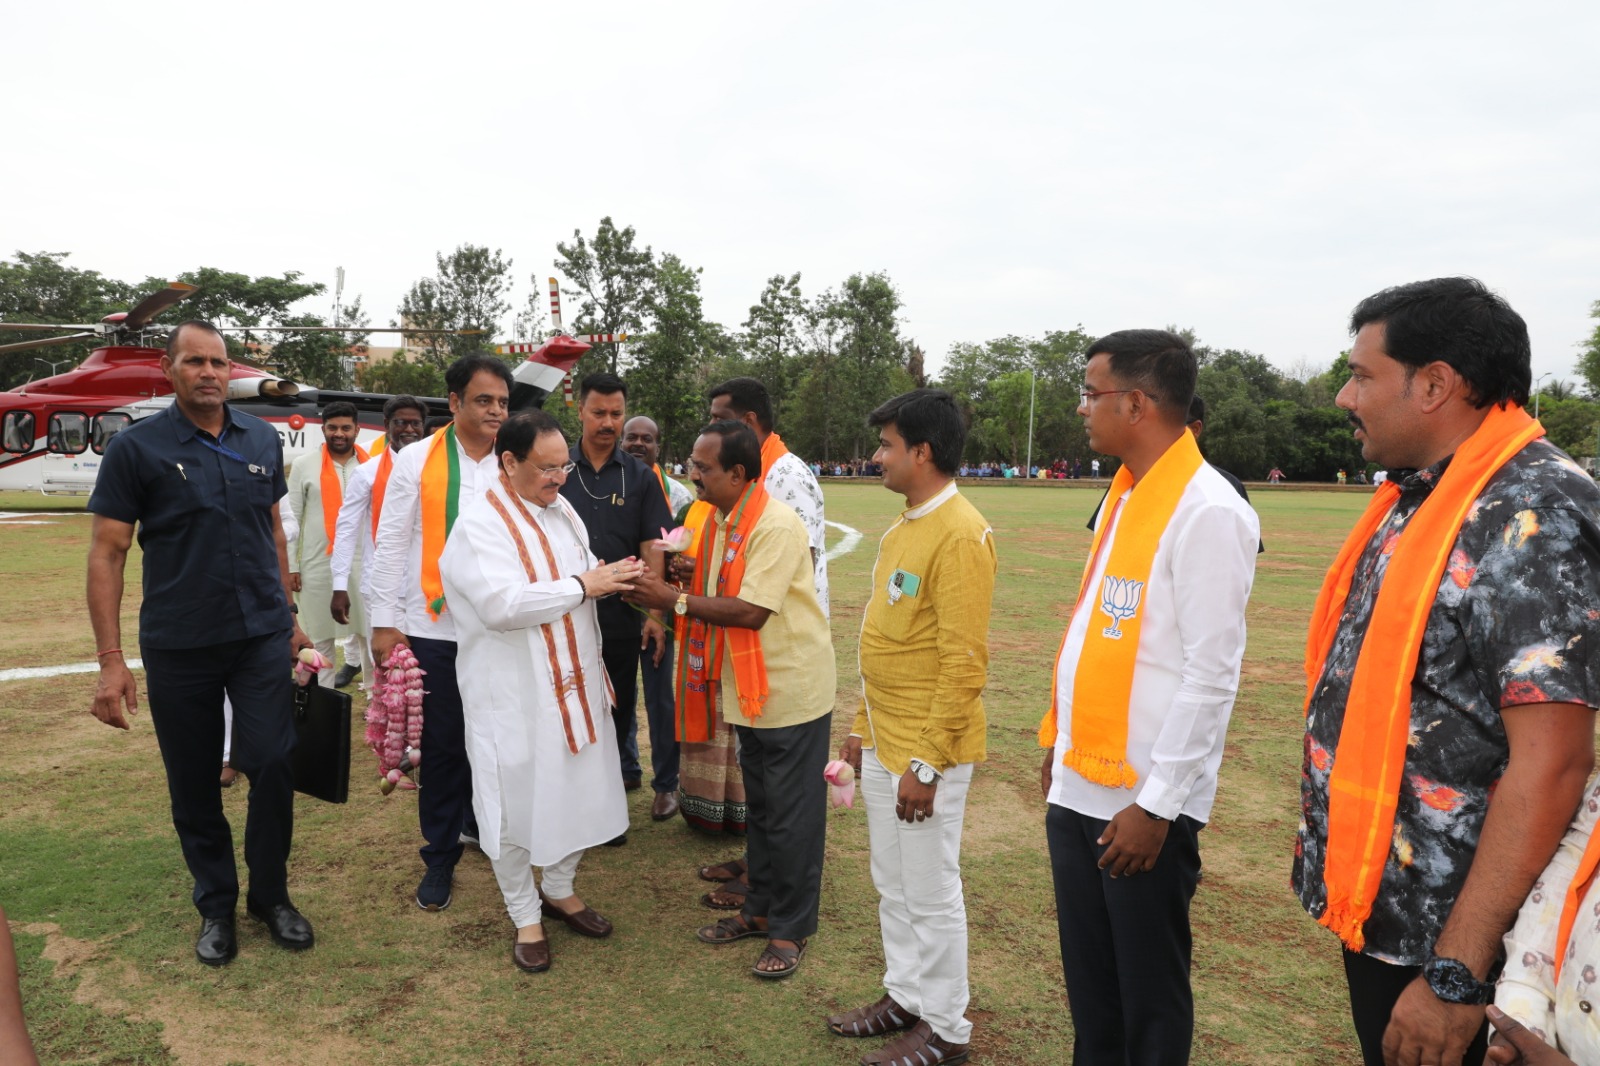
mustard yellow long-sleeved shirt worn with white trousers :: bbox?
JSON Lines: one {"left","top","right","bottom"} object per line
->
{"left": 851, "top": 482, "right": 998, "bottom": 773}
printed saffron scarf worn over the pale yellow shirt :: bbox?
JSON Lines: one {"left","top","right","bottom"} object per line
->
{"left": 674, "top": 480, "right": 768, "bottom": 744}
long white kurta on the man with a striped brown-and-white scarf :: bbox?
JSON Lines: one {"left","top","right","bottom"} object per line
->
{"left": 448, "top": 483, "right": 627, "bottom": 866}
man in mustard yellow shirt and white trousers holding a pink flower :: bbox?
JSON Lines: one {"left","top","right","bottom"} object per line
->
{"left": 827, "top": 389, "right": 997, "bottom": 1066}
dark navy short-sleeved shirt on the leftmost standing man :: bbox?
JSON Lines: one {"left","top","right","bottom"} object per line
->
{"left": 88, "top": 403, "right": 291, "bottom": 648}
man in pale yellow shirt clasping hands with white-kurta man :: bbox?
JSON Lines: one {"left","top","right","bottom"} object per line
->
{"left": 626, "top": 421, "right": 837, "bottom": 978}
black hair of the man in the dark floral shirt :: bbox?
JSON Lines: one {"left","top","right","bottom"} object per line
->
{"left": 1350, "top": 277, "right": 1533, "bottom": 408}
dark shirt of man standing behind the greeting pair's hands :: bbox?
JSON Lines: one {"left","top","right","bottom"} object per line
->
{"left": 562, "top": 442, "right": 672, "bottom": 635}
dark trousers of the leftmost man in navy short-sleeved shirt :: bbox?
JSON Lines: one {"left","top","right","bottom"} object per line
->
{"left": 139, "top": 631, "right": 294, "bottom": 917}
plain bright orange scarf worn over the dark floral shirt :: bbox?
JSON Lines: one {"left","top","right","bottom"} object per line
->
{"left": 1306, "top": 403, "right": 1544, "bottom": 951}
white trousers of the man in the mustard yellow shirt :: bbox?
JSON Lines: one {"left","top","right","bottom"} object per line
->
{"left": 861, "top": 747, "right": 973, "bottom": 1044}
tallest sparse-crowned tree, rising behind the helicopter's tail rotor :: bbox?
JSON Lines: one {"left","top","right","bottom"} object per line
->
{"left": 550, "top": 214, "right": 656, "bottom": 373}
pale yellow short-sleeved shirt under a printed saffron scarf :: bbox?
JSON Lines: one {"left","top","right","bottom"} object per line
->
{"left": 704, "top": 498, "right": 838, "bottom": 730}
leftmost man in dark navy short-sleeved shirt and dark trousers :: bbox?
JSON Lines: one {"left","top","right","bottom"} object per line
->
{"left": 88, "top": 322, "right": 314, "bottom": 967}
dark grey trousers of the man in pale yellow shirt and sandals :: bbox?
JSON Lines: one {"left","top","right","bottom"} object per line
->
{"left": 736, "top": 712, "right": 834, "bottom": 940}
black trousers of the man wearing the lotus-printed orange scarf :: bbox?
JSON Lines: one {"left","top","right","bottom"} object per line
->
{"left": 1045, "top": 804, "right": 1202, "bottom": 1066}
